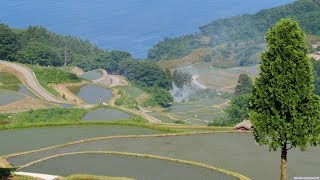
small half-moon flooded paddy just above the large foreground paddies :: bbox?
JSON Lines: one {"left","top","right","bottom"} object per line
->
{"left": 82, "top": 108, "right": 132, "bottom": 121}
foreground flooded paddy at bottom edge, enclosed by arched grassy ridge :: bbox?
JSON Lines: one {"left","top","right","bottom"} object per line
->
{"left": 22, "top": 154, "right": 236, "bottom": 180}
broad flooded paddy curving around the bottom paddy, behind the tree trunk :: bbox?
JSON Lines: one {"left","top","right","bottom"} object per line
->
{"left": 9, "top": 133, "right": 320, "bottom": 180}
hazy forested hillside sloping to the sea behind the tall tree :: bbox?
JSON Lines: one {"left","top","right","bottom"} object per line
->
{"left": 148, "top": 0, "right": 320, "bottom": 68}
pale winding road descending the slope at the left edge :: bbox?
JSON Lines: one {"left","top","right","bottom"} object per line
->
{"left": 0, "top": 60, "right": 66, "bottom": 103}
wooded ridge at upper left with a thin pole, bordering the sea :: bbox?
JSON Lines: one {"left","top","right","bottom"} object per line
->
{"left": 0, "top": 24, "right": 103, "bottom": 68}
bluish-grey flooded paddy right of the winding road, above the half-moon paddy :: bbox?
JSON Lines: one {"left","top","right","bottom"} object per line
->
{"left": 68, "top": 84, "right": 112, "bottom": 104}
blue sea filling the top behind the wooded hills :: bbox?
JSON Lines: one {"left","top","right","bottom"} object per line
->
{"left": 0, "top": 0, "right": 293, "bottom": 58}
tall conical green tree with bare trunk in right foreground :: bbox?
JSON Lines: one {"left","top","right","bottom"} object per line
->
{"left": 250, "top": 18, "right": 320, "bottom": 180}
